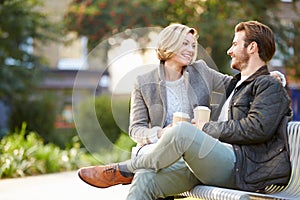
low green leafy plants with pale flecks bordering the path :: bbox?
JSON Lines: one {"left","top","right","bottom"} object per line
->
{"left": 0, "top": 123, "right": 135, "bottom": 178}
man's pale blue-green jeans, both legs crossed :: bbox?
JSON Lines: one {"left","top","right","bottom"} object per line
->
{"left": 125, "top": 122, "right": 236, "bottom": 200}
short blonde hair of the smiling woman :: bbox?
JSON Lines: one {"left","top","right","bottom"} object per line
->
{"left": 156, "top": 24, "right": 198, "bottom": 62}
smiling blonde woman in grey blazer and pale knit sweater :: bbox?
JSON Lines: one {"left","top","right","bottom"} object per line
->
{"left": 129, "top": 24, "right": 231, "bottom": 149}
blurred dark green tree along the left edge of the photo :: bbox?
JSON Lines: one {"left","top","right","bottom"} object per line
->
{"left": 0, "top": 0, "right": 60, "bottom": 134}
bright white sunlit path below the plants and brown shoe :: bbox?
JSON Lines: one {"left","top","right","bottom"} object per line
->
{"left": 0, "top": 171, "right": 130, "bottom": 200}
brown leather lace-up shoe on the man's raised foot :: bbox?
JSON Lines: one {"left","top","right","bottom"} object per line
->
{"left": 78, "top": 164, "right": 133, "bottom": 188}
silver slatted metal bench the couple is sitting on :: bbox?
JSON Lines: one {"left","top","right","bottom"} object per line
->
{"left": 181, "top": 121, "right": 300, "bottom": 200}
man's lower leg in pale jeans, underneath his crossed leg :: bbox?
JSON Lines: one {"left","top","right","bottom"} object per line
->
{"left": 127, "top": 159, "right": 200, "bottom": 200}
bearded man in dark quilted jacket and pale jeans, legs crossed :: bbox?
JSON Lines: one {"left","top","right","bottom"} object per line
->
{"left": 79, "top": 21, "right": 291, "bottom": 200}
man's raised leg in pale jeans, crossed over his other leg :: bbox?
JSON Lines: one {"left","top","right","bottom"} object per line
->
{"left": 126, "top": 122, "right": 235, "bottom": 187}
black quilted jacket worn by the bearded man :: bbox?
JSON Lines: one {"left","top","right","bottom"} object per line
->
{"left": 203, "top": 66, "right": 291, "bottom": 191}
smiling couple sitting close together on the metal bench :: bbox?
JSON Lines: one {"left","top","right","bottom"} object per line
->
{"left": 78, "top": 21, "right": 291, "bottom": 200}
